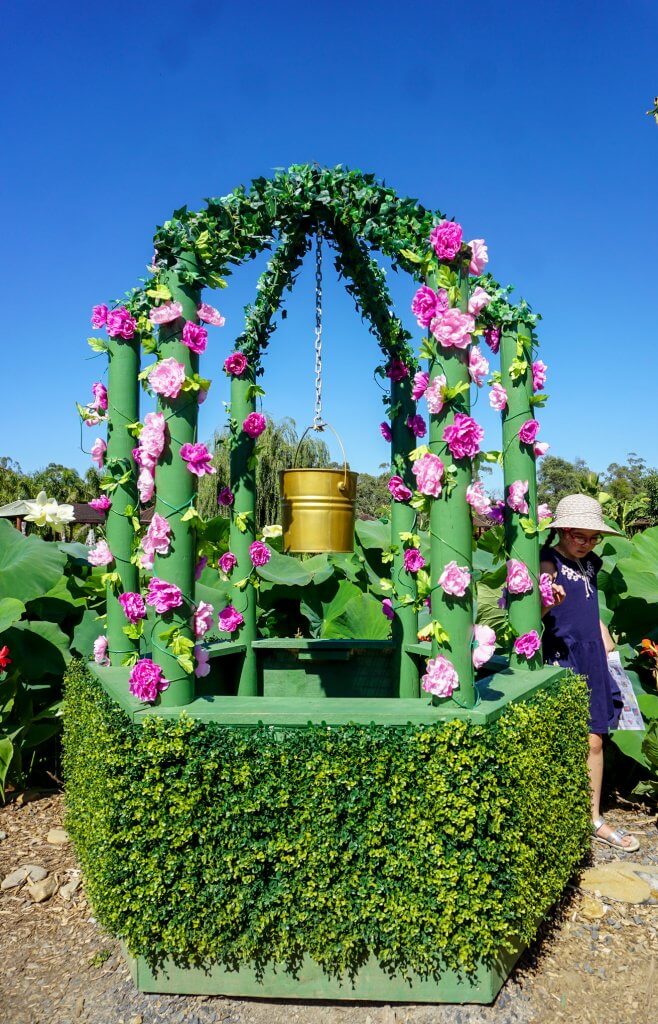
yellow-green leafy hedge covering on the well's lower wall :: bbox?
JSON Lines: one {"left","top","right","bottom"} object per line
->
{"left": 64, "top": 664, "right": 589, "bottom": 974}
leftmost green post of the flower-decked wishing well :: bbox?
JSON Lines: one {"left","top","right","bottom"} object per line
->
{"left": 106, "top": 338, "right": 139, "bottom": 665}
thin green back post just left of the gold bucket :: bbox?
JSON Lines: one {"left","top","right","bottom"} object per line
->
{"left": 229, "top": 373, "right": 258, "bottom": 697}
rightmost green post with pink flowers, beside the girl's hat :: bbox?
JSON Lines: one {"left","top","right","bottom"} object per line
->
{"left": 500, "top": 325, "right": 542, "bottom": 669}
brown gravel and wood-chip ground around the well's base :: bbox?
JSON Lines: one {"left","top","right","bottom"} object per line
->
{"left": 0, "top": 794, "right": 658, "bottom": 1024}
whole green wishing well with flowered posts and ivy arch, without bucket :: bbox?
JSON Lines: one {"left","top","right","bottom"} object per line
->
{"left": 65, "top": 166, "right": 589, "bottom": 1001}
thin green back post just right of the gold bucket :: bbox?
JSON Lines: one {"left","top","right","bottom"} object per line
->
{"left": 391, "top": 377, "right": 421, "bottom": 697}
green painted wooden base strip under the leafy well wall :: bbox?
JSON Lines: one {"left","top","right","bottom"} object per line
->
{"left": 124, "top": 948, "right": 523, "bottom": 1002}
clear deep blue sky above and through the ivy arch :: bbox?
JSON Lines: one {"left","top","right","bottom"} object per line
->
{"left": 0, "top": 0, "right": 658, "bottom": 485}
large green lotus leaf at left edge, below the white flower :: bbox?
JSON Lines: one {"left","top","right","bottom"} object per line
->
{"left": 0, "top": 519, "right": 67, "bottom": 604}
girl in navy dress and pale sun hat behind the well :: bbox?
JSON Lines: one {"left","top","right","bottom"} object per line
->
{"left": 540, "top": 495, "right": 640, "bottom": 853}
